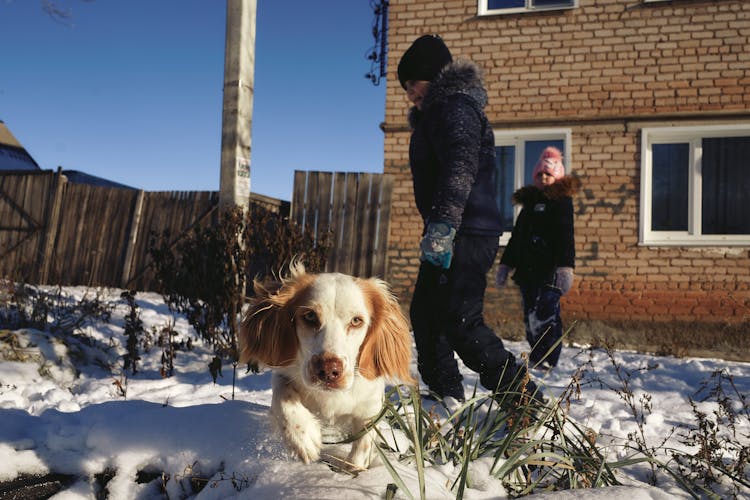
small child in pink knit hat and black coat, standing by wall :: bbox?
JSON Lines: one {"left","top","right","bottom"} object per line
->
{"left": 495, "top": 147, "right": 581, "bottom": 368}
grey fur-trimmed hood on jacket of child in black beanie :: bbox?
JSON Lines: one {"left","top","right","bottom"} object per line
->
{"left": 409, "top": 59, "right": 487, "bottom": 128}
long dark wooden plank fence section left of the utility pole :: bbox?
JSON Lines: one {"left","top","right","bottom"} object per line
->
{"left": 0, "top": 171, "right": 218, "bottom": 289}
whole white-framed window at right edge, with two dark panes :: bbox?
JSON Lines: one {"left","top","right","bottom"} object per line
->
{"left": 640, "top": 124, "right": 750, "bottom": 245}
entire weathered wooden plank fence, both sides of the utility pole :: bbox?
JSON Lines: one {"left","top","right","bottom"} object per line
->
{"left": 0, "top": 170, "right": 392, "bottom": 290}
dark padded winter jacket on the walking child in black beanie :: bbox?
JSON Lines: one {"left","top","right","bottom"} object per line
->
{"left": 409, "top": 61, "right": 502, "bottom": 236}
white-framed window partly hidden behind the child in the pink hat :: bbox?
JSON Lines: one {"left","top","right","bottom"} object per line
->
{"left": 495, "top": 129, "right": 570, "bottom": 244}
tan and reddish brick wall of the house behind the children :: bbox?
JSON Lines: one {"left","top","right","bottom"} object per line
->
{"left": 384, "top": 0, "right": 750, "bottom": 332}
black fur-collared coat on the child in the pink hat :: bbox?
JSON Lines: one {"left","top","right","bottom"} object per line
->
{"left": 500, "top": 176, "right": 581, "bottom": 286}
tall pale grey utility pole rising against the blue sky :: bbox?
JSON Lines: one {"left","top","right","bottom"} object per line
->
{"left": 219, "top": 0, "right": 257, "bottom": 210}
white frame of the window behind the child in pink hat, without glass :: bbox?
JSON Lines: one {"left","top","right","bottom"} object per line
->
{"left": 493, "top": 128, "right": 573, "bottom": 246}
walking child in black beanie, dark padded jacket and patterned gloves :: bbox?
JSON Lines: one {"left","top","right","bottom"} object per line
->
{"left": 398, "top": 35, "right": 544, "bottom": 403}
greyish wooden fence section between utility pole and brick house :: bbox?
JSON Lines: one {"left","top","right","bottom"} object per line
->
{"left": 291, "top": 170, "right": 393, "bottom": 278}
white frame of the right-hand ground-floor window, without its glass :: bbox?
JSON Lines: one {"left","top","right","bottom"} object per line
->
{"left": 639, "top": 124, "right": 750, "bottom": 246}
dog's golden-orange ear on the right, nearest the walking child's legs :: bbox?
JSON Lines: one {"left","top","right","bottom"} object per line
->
{"left": 359, "top": 278, "right": 415, "bottom": 384}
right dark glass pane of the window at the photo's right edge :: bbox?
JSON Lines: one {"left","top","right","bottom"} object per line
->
{"left": 701, "top": 137, "right": 750, "bottom": 234}
